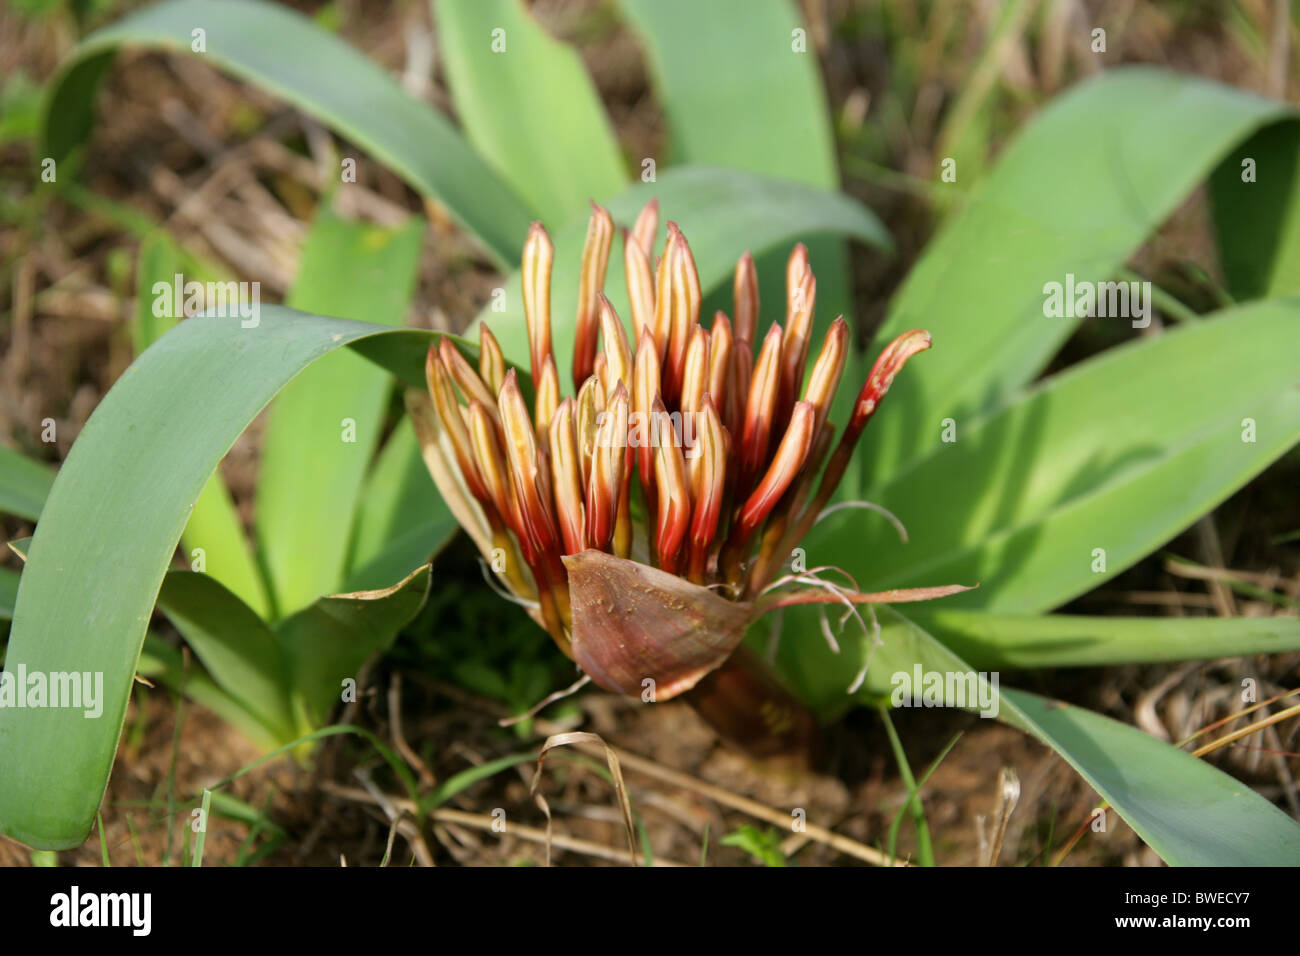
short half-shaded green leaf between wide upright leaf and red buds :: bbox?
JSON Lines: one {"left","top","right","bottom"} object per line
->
{"left": 343, "top": 416, "right": 460, "bottom": 591}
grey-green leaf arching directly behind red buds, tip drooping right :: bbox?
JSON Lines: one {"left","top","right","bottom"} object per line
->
{"left": 469, "top": 166, "right": 889, "bottom": 384}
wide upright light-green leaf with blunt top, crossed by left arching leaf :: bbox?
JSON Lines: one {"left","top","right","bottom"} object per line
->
{"left": 255, "top": 206, "right": 428, "bottom": 617}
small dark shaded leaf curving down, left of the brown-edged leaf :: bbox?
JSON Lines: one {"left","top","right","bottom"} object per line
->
{"left": 157, "top": 571, "right": 296, "bottom": 743}
